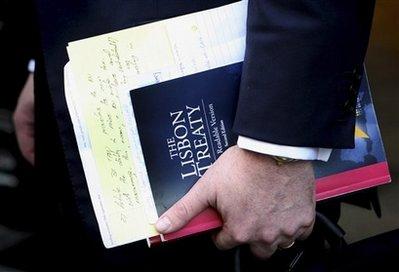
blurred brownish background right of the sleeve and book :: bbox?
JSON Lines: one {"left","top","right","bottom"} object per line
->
{"left": 339, "top": 0, "right": 399, "bottom": 242}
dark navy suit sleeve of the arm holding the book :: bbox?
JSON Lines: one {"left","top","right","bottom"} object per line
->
{"left": 234, "top": 0, "right": 374, "bottom": 148}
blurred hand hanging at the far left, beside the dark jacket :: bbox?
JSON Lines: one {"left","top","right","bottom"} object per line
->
{"left": 14, "top": 74, "right": 35, "bottom": 165}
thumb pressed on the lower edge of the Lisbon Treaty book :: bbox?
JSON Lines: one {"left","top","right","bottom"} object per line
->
{"left": 155, "top": 175, "right": 215, "bottom": 234}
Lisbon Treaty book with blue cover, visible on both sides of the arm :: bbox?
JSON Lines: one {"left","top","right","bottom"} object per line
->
{"left": 130, "top": 63, "right": 390, "bottom": 218}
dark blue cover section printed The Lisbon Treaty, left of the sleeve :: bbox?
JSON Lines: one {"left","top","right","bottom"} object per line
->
{"left": 131, "top": 63, "right": 242, "bottom": 214}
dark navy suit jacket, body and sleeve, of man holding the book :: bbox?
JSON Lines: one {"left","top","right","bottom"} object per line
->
{"left": 35, "top": 0, "right": 374, "bottom": 268}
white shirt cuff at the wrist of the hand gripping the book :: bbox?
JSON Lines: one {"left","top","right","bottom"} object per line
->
{"left": 237, "top": 136, "right": 332, "bottom": 161}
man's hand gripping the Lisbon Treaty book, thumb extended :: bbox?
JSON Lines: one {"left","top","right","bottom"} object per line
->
{"left": 156, "top": 146, "right": 315, "bottom": 258}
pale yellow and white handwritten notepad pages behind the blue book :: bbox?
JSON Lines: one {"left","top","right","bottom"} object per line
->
{"left": 65, "top": 0, "right": 247, "bottom": 248}
